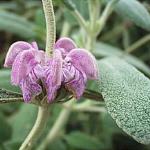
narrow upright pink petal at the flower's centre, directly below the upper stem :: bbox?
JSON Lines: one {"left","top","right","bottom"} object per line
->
{"left": 44, "top": 50, "right": 63, "bottom": 102}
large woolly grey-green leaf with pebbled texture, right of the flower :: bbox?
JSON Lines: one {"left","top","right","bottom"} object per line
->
{"left": 98, "top": 57, "right": 150, "bottom": 144}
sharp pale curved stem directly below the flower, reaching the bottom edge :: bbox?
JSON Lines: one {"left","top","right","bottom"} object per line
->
{"left": 19, "top": 107, "right": 48, "bottom": 150}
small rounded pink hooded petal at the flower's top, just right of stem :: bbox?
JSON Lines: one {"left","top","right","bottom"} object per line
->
{"left": 55, "top": 37, "right": 76, "bottom": 53}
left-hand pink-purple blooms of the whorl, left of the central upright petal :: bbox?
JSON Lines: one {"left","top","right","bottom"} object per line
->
{"left": 4, "top": 41, "right": 45, "bottom": 102}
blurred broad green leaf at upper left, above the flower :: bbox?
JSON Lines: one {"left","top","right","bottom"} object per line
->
{"left": 0, "top": 11, "right": 35, "bottom": 38}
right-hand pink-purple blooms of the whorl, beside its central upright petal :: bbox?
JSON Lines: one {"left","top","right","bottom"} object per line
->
{"left": 55, "top": 38, "right": 98, "bottom": 99}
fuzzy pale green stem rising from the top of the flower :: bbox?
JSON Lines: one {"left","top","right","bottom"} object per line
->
{"left": 42, "top": 0, "right": 56, "bottom": 56}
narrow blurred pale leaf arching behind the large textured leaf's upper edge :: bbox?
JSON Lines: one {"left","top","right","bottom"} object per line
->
{"left": 93, "top": 42, "right": 150, "bottom": 77}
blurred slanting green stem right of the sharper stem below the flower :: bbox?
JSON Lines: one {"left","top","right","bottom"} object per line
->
{"left": 38, "top": 100, "right": 75, "bottom": 150}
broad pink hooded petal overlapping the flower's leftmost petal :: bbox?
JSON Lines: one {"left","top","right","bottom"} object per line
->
{"left": 11, "top": 50, "right": 37, "bottom": 85}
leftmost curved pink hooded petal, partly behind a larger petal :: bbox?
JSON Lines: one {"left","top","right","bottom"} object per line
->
{"left": 4, "top": 41, "right": 32, "bottom": 67}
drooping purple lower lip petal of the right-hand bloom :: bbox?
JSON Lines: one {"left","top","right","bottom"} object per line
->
{"left": 65, "top": 70, "right": 87, "bottom": 99}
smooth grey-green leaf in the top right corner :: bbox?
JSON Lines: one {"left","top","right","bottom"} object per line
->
{"left": 116, "top": 0, "right": 150, "bottom": 31}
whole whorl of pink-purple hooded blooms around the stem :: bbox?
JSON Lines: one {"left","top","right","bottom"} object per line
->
{"left": 4, "top": 38, "right": 98, "bottom": 102}
